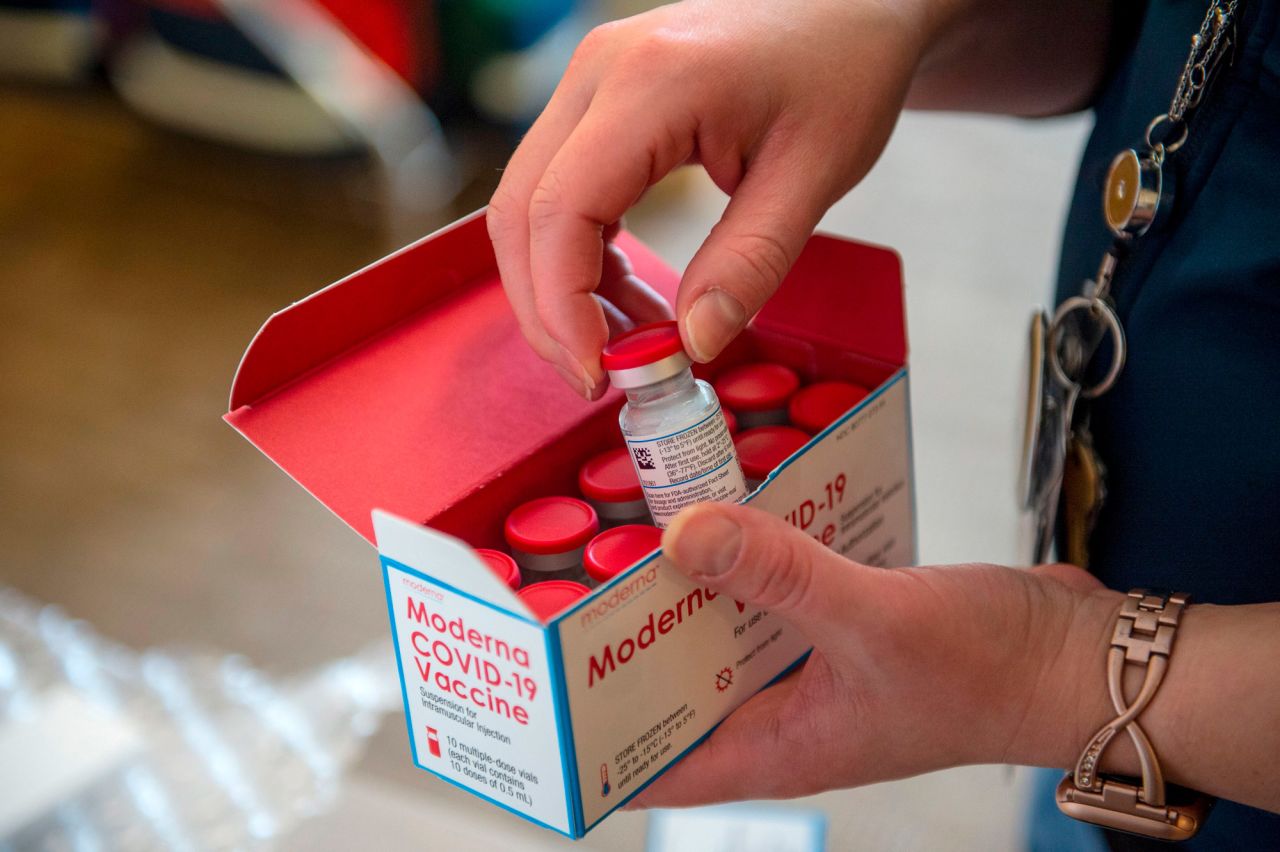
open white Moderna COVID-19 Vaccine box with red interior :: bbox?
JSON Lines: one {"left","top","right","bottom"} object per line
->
{"left": 227, "top": 212, "right": 915, "bottom": 838}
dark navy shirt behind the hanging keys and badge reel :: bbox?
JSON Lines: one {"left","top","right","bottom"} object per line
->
{"left": 1057, "top": 0, "right": 1280, "bottom": 851}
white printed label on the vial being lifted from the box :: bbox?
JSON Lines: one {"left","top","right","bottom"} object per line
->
{"left": 626, "top": 408, "right": 748, "bottom": 528}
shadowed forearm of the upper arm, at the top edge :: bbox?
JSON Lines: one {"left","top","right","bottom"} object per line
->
{"left": 902, "top": 0, "right": 1112, "bottom": 115}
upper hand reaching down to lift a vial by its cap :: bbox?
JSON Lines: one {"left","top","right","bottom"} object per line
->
{"left": 488, "top": 0, "right": 929, "bottom": 399}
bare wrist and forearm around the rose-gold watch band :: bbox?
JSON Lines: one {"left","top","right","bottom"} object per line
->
{"left": 1006, "top": 591, "right": 1280, "bottom": 811}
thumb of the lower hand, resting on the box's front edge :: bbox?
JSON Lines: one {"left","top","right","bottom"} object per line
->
{"left": 662, "top": 503, "right": 865, "bottom": 646}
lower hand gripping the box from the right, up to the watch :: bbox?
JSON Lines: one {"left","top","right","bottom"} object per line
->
{"left": 630, "top": 503, "right": 1123, "bottom": 807}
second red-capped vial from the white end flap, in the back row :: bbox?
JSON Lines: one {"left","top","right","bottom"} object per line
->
{"left": 503, "top": 496, "right": 600, "bottom": 583}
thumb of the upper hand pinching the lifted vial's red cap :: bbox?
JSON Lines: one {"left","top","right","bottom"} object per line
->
{"left": 676, "top": 150, "right": 833, "bottom": 363}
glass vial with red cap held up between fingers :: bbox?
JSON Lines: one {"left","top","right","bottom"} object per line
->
{"left": 600, "top": 322, "right": 748, "bottom": 528}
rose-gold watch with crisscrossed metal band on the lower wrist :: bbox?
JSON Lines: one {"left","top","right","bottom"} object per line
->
{"left": 1057, "top": 588, "right": 1211, "bottom": 840}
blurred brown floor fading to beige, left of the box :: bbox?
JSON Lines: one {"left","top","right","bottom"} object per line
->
{"left": 0, "top": 86, "right": 504, "bottom": 669}
